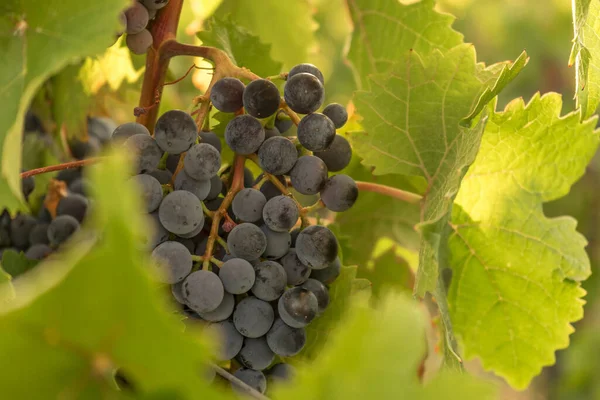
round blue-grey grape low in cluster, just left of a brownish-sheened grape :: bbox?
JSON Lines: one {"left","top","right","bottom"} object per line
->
{"left": 233, "top": 296, "right": 275, "bottom": 338}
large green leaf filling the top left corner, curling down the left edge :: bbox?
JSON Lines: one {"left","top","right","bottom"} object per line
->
{"left": 0, "top": 0, "right": 129, "bottom": 211}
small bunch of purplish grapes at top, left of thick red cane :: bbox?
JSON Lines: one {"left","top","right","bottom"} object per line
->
{"left": 119, "top": 0, "right": 169, "bottom": 54}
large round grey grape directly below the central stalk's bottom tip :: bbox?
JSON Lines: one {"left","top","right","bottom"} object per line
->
{"left": 182, "top": 270, "right": 225, "bottom": 313}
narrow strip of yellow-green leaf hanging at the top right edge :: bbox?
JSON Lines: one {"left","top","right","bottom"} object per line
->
{"left": 569, "top": 0, "right": 600, "bottom": 119}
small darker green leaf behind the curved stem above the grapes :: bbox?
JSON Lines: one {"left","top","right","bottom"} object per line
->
{"left": 198, "top": 16, "right": 281, "bottom": 76}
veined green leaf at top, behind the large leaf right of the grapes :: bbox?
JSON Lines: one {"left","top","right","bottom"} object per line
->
{"left": 348, "top": 0, "right": 462, "bottom": 89}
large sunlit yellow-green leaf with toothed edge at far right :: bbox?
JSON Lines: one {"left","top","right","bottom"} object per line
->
{"left": 448, "top": 93, "right": 598, "bottom": 388}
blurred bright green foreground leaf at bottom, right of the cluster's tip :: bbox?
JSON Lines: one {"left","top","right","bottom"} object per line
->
{"left": 273, "top": 295, "right": 495, "bottom": 400}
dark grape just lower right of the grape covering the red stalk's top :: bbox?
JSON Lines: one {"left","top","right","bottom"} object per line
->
{"left": 258, "top": 136, "right": 298, "bottom": 175}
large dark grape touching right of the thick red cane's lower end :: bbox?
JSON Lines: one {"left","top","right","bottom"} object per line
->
{"left": 154, "top": 110, "right": 198, "bottom": 154}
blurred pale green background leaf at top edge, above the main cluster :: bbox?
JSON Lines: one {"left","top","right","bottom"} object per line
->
{"left": 215, "top": 0, "right": 315, "bottom": 69}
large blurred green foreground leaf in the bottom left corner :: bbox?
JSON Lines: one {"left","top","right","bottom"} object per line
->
{"left": 0, "top": 151, "right": 231, "bottom": 399}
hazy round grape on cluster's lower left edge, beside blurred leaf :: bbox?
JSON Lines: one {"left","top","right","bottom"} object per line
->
{"left": 152, "top": 241, "right": 193, "bottom": 284}
